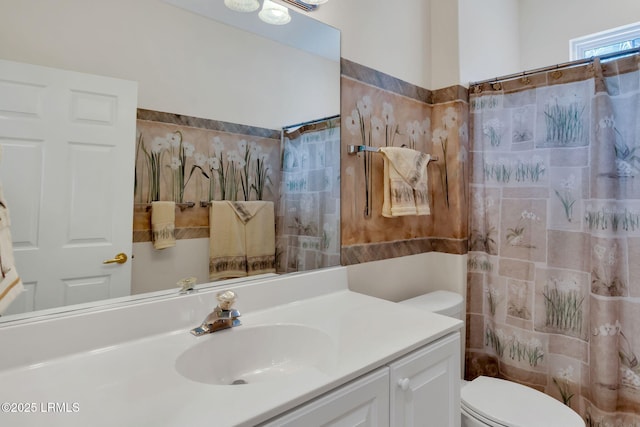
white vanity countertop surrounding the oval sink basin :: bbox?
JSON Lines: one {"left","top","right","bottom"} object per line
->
{"left": 0, "top": 270, "right": 461, "bottom": 427}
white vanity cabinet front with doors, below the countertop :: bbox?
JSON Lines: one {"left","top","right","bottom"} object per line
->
{"left": 262, "top": 333, "right": 460, "bottom": 427}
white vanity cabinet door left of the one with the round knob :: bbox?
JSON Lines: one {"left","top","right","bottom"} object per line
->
{"left": 263, "top": 367, "right": 389, "bottom": 427}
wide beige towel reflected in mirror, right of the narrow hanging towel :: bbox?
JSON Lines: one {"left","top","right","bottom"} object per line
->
{"left": 209, "top": 201, "right": 275, "bottom": 280}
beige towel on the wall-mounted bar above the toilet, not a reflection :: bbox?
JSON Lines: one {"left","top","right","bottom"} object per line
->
{"left": 379, "top": 147, "right": 431, "bottom": 218}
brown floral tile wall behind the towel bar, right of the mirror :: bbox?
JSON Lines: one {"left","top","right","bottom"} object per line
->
{"left": 341, "top": 59, "right": 469, "bottom": 265}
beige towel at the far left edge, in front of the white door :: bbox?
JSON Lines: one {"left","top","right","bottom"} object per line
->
{"left": 0, "top": 187, "right": 24, "bottom": 314}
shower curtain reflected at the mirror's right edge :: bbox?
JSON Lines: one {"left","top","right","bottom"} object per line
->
{"left": 276, "top": 117, "right": 340, "bottom": 273}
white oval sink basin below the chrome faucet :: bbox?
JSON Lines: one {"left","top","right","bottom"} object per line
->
{"left": 175, "top": 324, "right": 334, "bottom": 385}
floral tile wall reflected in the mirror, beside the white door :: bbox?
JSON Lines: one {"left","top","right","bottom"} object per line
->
{"left": 133, "top": 110, "right": 280, "bottom": 242}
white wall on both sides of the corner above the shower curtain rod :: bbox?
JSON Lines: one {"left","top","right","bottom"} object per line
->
{"left": 456, "top": 0, "right": 640, "bottom": 87}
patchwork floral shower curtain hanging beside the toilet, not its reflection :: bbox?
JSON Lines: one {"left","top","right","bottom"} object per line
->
{"left": 466, "top": 56, "right": 640, "bottom": 426}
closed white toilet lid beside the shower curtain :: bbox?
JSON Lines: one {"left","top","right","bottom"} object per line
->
{"left": 460, "top": 376, "right": 585, "bottom": 427}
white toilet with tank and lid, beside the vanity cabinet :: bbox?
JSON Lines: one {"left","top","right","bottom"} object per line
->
{"left": 400, "top": 291, "right": 585, "bottom": 427}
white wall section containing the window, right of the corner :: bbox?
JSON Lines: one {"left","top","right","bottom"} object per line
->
{"left": 524, "top": 0, "right": 640, "bottom": 72}
